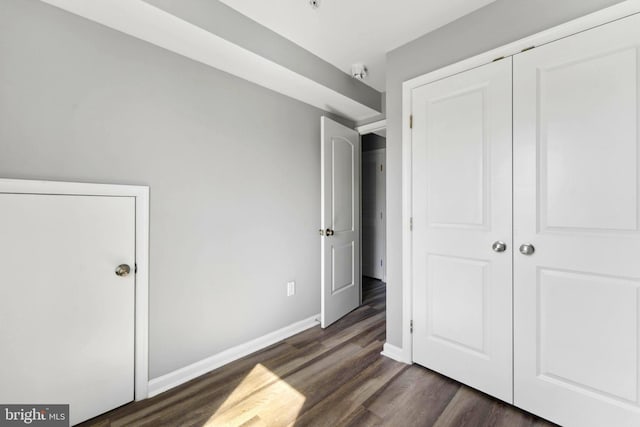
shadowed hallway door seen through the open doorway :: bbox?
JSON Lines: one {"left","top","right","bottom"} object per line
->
{"left": 362, "top": 148, "right": 386, "bottom": 280}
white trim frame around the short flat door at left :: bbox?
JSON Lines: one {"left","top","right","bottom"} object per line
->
{"left": 0, "top": 179, "right": 149, "bottom": 401}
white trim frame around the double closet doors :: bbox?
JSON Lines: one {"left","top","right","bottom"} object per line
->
{"left": 398, "top": 0, "right": 640, "bottom": 363}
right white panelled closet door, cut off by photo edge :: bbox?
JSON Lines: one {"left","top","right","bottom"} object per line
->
{"left": 514, "top": 16, "right": 640, "bottom": 427}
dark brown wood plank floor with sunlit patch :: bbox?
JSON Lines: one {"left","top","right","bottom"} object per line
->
{"left": 83, "top": 279, "right": 553, "bottom": 427}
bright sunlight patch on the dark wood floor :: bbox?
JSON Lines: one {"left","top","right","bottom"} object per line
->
{"left": 204, "top": 364, "right": 306, "bottom": 427}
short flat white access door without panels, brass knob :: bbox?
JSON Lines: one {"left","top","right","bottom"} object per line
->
{"left": 0, "top": 193, "right": 135, "bottom": 424}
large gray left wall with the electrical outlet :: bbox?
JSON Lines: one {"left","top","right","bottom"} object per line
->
{"left": 0, "top": 0, "right": 350, "bottom": 378}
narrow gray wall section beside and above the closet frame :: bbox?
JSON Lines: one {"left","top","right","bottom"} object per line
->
{"left": 386, "top": 0, "right": 619, "bottom": 346}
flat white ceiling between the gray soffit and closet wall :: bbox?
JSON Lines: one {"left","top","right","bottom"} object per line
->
{"left": 220, "top": 0, "right": 495, "bottom": 92}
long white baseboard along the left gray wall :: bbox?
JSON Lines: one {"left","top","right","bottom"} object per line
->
{"left": 148, "top": 314, "right": 320, "bottom": 397}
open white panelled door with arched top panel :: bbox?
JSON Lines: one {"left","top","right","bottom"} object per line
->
{"left": 320, "top": 117, "right": 362, "bottom": 328}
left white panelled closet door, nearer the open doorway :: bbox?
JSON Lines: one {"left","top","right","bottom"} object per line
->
{"left": 412, "top": 58, "right": 513, "bottom": 402}
